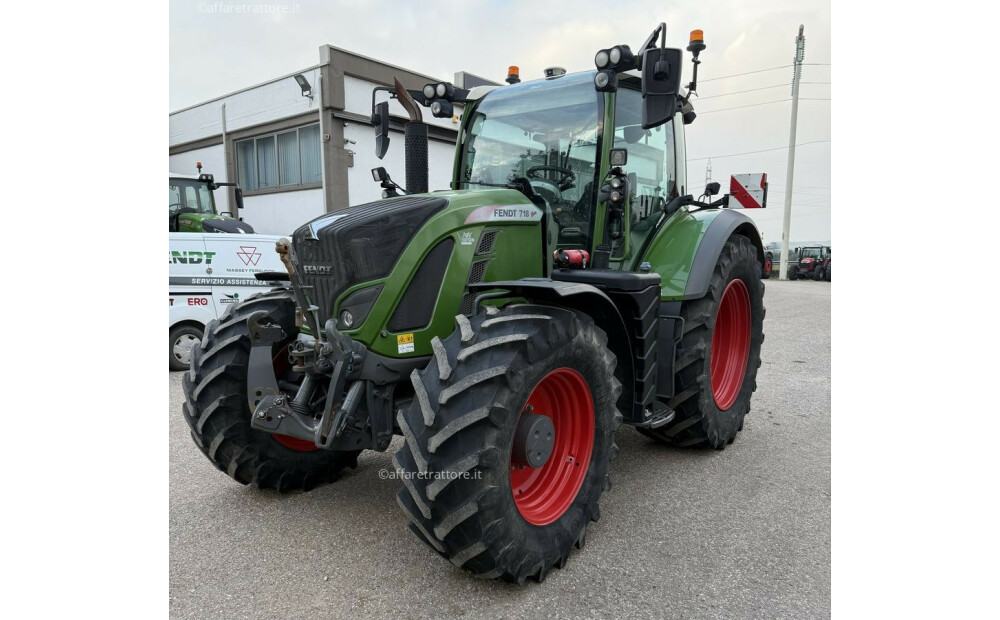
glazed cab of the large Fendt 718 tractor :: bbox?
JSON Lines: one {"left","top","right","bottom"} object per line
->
{"left": 452, "top": 71, "right": 685, "bottom": 269}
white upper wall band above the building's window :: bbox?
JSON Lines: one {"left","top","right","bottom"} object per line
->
{"left": 170, "top": 68, "right": 320, "bottom": 146}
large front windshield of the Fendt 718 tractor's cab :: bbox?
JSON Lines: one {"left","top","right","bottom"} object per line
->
{"left": 456, "top": 73, "right": 603, "bottom": 252}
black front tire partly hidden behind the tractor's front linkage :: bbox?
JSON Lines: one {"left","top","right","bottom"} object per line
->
{"left": 183, "top": 289, "right": 360, "bottom": 491}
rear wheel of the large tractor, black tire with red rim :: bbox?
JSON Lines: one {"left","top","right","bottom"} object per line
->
{"left": 639, "top": 235, "right": 764, "bottom": 450}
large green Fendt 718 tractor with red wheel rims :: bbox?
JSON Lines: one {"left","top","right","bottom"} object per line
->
{"left": 183, "top": 24, "right": 764, "bottom": 583}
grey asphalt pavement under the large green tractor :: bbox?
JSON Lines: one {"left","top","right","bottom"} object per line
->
{"left": 169, "top": 279, "right": 831, "bottom": 618}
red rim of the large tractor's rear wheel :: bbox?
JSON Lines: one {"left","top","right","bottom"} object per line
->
{"left": 712, "top": 278, "right": 750, "bottom": 411}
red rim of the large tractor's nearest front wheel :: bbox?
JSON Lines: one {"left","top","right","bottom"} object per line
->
{"left": 510, "top": 368, "right": 594, "bottom": 525}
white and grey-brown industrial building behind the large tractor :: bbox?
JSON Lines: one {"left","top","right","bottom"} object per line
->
{"left": 170, "top": 45, "right": 494, "bottom": 234}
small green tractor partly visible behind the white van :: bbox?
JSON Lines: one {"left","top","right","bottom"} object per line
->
{"left": 168, "top": 162, "right": 254, "bottom": 233}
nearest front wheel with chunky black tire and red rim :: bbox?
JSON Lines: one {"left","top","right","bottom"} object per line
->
{"left": 394, "top": 305, "right": 622, "bottom": 583}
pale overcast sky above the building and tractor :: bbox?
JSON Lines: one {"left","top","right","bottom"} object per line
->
{"left": 169, "top": 0, "right": 832, "bottom": 242}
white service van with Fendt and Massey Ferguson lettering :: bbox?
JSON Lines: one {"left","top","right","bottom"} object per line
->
{"left": 169, "top": 233, "right": 285, "bottom": 370}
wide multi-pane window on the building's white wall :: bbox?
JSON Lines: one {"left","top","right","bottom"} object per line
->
{"left": 236, "top": 123, "right": 322, "bottom": 192}
